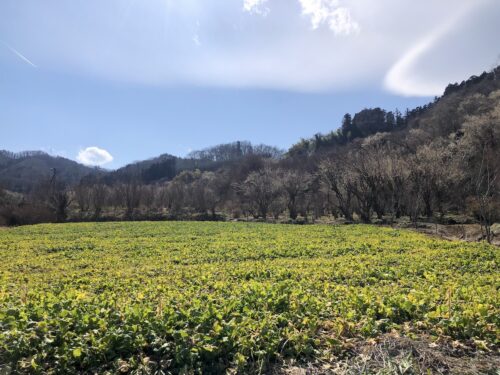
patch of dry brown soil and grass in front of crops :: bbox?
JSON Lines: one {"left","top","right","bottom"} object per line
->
{"left": 273, "top": 334, "right": 500, "bottom": 375}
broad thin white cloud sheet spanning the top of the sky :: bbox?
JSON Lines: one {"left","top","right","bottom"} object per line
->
{"left": 0, "top": 0, "right": 500, "bottom": 95}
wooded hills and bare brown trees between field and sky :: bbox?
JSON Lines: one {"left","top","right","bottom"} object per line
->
{"left": 0, "top": 67, "right": 500, "bottom": 241}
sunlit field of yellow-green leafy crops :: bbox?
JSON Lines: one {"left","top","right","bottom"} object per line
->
{"left": 0, "top": 222, "right": 500, "bottom": 373}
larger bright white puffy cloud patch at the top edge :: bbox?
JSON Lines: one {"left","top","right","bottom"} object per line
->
{"left": 299, "top": 0, "right": 360, "bottom": 35}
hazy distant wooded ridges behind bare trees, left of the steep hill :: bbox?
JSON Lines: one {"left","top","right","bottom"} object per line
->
{"left": 0, "top": 141, "right": 283, "bottom": 193}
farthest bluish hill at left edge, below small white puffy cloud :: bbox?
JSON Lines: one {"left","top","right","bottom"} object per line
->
{"left": 0, "top": 150, "right": 97, "bottom": 193}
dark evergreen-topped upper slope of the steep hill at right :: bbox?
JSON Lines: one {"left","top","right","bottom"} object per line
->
{"left": 288, "top": 66, "right": 500, "bottom": 156}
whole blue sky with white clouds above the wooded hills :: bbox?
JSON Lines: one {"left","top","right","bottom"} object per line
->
{"left": 0, "top": 0, "right": 500, "bottom": 168}
